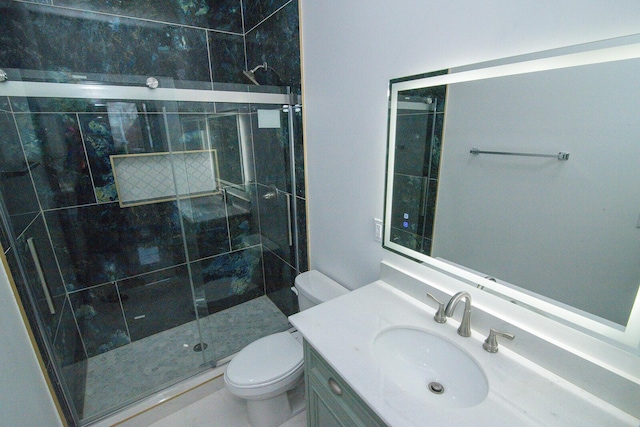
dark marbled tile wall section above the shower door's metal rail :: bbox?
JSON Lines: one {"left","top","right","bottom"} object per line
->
{"left": 0, "top": 0, "right": 300, "bottom": 88}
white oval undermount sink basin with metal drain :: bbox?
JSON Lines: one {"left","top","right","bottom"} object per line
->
{"left": 373, "top": 328, "right": 489, "bottom": 408}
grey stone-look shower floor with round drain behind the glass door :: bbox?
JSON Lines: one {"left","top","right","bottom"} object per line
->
{"left": 83, "top": 296, "right": 290, "bottom": 418}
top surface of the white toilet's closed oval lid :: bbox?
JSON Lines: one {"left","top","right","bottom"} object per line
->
{"left": 226, "top": 332, "right": 303, "bottom": 387}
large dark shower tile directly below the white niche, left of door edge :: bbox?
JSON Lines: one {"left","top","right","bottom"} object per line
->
{"left": 45, "top": 202, "right": 185, "bottom": 289}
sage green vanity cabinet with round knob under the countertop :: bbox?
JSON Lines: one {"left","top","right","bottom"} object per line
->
{"left": 304, "top": 341, "right": 386, "bottom": 427}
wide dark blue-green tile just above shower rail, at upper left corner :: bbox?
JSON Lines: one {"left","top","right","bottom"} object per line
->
{"left": 0, "top": 2, "right": 210, "bottom": 82}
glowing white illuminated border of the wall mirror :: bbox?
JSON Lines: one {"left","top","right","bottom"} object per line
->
{"left": 382, "top": 34, "right": 640, "bottom": 355}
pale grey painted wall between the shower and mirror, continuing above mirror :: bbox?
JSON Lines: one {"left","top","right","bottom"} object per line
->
{"left": 300, "top": 0, "right": 640, "bottom": 288}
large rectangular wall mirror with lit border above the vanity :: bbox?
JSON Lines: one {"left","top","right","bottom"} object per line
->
{"left": 383, "top": 35, "right": 640, "bottom": 354}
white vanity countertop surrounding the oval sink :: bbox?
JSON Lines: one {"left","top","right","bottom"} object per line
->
{"left": 289, "top": 281, "right": 640, "bottom": 427}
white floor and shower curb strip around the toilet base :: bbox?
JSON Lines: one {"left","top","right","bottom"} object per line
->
{"left": 94, "top": 376, "right": 307, "bottom": 427}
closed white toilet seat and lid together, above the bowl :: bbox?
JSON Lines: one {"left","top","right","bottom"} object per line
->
{"left": 224, "top": 332, "right": 304, "bottom": 398}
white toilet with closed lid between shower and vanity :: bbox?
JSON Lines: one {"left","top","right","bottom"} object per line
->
{"left": 224, "top": 270, "right": 349, "bottom": 427}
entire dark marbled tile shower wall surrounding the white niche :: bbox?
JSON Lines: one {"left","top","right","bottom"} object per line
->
{"left": 0, "top": 0, "right": 307, "bottom": 422}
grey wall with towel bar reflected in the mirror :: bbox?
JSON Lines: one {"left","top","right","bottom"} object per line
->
{"left": 432, "top": 60, "right": 640, "bottom": 325}
